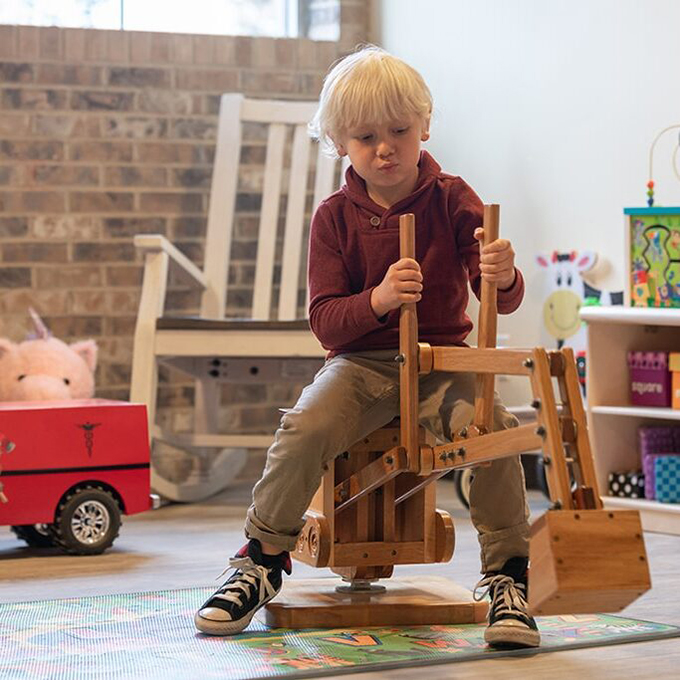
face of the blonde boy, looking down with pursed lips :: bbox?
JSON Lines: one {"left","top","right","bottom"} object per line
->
{"left": 335, "top": 114, "right": 429, "bottom": 207}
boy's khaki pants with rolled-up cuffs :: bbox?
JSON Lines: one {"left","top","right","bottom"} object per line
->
{"left": 246, "top": 350, "right": 529, "bottom": 573}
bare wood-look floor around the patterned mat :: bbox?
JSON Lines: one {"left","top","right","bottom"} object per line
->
{"left": 0, "top": 480, "right": 680, "bottom": 680}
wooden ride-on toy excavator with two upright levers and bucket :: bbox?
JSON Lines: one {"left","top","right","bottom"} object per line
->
{"left": 266, "top": 205, "right": 651, "bottom": 628}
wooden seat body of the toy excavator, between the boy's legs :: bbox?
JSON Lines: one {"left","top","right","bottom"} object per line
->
{"left": 295, "top": 421, "right": 454, "bottom": 589}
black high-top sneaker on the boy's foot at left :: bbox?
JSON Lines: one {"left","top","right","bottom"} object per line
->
{"left": 194, "top": 539, "right": 291, "bottom": 635}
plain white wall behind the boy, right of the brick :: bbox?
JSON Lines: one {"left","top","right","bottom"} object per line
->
{"left": 372, "top": 0, "right": 680, "bottom": 394}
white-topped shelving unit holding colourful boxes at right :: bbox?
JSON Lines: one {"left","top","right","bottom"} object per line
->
{"left": 581, "top": 307, "right": 680, "bottom": 535}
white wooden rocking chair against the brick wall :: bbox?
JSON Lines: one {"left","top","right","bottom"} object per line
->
{"left": 130, "top": 94, "right": 346, "bottom": 502}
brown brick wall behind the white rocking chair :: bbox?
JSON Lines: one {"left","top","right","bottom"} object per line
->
{"left": 0, "top": 0, "right": 368, "bottom": 478}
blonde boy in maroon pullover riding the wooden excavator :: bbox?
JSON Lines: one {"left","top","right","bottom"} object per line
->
{"left": 195, "top": 47, "right": 540, "bottom": 646}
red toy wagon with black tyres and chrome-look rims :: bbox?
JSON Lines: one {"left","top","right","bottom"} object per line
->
{"left": 0, "top": 399, "right": 153, "bottom": 555}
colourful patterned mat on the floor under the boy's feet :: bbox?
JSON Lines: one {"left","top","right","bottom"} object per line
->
{"left": 0, "top": 588, "right": 680, "bottom": 680}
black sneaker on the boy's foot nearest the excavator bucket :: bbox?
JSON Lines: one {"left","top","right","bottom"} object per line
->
{"left": 474, "top": 557, "right": 541, "bottom": 648}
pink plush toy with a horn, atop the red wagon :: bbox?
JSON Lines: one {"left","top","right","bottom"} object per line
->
{"left": 0, "top": 309, "right": 97, "bottom": 401}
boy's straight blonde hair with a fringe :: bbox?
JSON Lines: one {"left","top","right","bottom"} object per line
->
{"left": 308, "top": 45, "right": 432, "bottom": 157}
